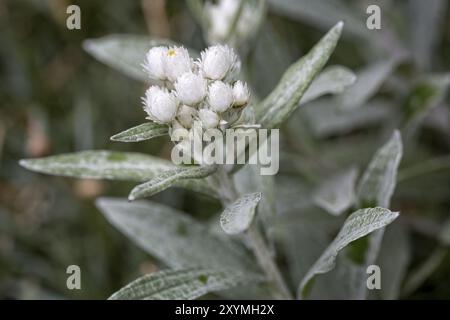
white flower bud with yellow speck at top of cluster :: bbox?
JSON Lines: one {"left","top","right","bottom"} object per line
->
{"left": 163, "top": 47, "right": 193, "bottom": 82}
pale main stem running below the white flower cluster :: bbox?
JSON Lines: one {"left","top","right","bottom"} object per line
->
{"left": 218, "top": 168, "right": 293, "bottom": 300}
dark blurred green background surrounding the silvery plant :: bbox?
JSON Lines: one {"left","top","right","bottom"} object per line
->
{"left": 0, "top": 0, "right": 450, "bottom": 299}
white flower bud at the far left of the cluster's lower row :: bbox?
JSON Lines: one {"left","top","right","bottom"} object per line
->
{"left": 143, "top": 86, "right": 178, "bottom": 123}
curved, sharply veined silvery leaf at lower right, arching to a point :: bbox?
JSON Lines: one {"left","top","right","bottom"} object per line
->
{"left": 298, "top": 207, "right": 398, "bottom": 298}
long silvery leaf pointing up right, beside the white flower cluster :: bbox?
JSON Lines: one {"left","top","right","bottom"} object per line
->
{"left": 255, "top": 22, "right": 343, "bottom": 129}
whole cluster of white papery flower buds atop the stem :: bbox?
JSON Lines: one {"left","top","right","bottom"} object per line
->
{"left": 143, "top": 45, "right": 250, "bottom": 130}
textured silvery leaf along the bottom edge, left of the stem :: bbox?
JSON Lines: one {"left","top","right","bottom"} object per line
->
{"left": 109, "top": 268, "right": 261, "bottom": 300}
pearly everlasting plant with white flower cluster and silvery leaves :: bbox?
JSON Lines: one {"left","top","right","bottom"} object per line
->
{"left": 21, "top": 19, "right": 414, "bottom": 299}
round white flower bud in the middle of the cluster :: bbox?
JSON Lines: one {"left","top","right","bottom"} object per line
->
{"left": 174, "top": 72, "right": 207, "bottom": 105}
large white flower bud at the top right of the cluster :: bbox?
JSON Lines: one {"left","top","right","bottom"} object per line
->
{"left": 200, "top": 45, "right": 241, "bottom": 80}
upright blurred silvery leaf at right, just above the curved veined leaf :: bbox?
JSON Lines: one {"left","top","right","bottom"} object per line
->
{"left": 357, "top": 131, "right": 403, "bottom": 207}
